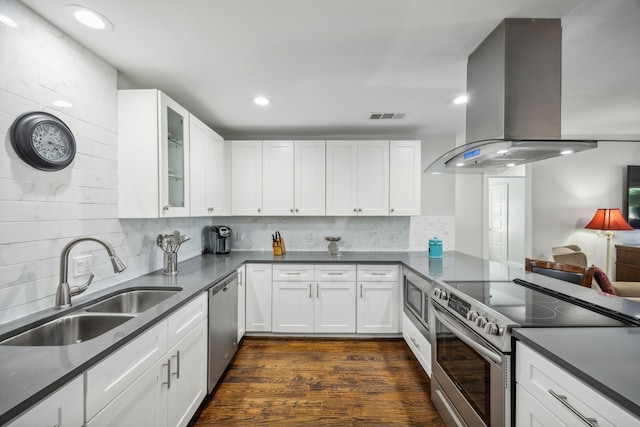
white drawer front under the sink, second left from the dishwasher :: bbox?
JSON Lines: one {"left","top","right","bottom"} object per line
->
{"left": 85, "top": 320, "right": 168, "bottom": 421}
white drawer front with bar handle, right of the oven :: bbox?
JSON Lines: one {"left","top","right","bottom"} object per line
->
{"left": 516, "top": 341, "right": 640, "bottom": 427}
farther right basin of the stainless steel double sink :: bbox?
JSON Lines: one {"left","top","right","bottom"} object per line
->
{"left": 85, "top": 288, "right": 181, "bottom": 314}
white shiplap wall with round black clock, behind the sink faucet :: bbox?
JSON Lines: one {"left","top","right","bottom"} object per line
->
{"left": 0, "top": 0, "right": 211, "bottom": 323}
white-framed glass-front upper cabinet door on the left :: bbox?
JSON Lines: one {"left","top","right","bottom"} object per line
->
{"left": 159, "top": 92, "right": 189, "bottom": 217}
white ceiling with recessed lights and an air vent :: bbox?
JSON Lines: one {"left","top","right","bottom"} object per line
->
{"left": 17, "top": 0, "right": 640, "bottom": 138}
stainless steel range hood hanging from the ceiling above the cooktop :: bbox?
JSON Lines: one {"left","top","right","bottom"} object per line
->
{"left": 425, "top": 19, "right": 598, "bottom": 173}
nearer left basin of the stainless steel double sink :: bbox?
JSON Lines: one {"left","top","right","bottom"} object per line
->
{"left": 0, "top": 313, "right": 134, "bottom": 346}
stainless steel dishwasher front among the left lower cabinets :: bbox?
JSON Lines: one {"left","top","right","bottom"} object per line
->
{"left": 208, "top": 272, "right": 238, "bottom": 393}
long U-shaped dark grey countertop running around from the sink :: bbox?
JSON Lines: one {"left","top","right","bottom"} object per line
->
{"left": 0, "top": 251, "right": 640, "bottom": 424}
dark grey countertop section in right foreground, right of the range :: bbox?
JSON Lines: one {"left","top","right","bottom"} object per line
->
{"left": 513, "top": 327, "right": 640, "bottom": 416}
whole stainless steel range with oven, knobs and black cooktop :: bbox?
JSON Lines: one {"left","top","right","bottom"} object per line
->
{"left": 430, "top": 281, "right": 626, "bottom": 427}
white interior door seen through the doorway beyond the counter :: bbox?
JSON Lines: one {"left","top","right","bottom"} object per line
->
{"left": 488, "top": 183, "right": 509, "bottom": 264}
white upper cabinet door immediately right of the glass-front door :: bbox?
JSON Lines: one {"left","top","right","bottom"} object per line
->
{"left": 189, "top": 114, "right": 231, "bottom": 216}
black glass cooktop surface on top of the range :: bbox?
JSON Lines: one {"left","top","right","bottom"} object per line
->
{"left": 446, "top": 281, "right": 628, "bottom": 327}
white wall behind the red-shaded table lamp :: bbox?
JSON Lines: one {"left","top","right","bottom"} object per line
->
{"left": 531, "top": 142, "right": 640, "bottom": 273}
